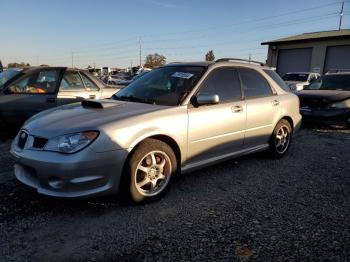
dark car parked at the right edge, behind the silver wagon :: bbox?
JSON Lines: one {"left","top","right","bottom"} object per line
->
{"left": 297, "top": 72, "right": 350, "bottom": 127}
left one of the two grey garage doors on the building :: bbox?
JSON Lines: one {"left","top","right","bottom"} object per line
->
{"left": 277, "top": 48, "right": 312, "bottom": 76}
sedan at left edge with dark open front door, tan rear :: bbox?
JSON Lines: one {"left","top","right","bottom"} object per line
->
{"left": 0, "top": 67, "right": 120, "bottom": 129}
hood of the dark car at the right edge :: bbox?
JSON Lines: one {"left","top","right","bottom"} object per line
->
{"left": 297, "top": 90, "right": 350, "bottom": 102}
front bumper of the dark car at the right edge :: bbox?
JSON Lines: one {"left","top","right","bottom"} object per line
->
{"left": 300, "top": 108, "right": 350, "bottom": 125}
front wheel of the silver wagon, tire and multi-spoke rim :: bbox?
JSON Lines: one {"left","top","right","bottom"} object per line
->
{"left": 124, "top": 139, "right": 177, "bottom": 203}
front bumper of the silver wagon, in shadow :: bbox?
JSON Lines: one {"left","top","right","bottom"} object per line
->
{"left": 11, "top": 142, "right": 128, "bottom": 198}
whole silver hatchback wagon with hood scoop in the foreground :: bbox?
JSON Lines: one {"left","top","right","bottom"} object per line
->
{"left": 11, "top": 60, "right": 301, "bottom": 202}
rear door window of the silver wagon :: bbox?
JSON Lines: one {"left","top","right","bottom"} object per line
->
{"left": 239, "top": 68, "right": 273, "bottom": 98}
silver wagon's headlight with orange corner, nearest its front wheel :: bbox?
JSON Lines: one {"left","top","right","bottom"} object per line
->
{"left": 44, "top": 131, "right": 99, "bottom": 154}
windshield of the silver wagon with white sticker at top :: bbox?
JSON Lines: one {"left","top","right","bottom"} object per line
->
{"left": 113, "top": 66, "right": 206, "bottom": 106}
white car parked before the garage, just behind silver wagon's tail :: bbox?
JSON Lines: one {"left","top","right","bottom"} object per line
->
{"left": 282, "top": 72, "right": 321, "bottom": 92}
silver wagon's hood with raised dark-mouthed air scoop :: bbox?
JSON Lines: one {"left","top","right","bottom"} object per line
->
{"left": 23, "top": 99, "right": 168, "bottom": 138}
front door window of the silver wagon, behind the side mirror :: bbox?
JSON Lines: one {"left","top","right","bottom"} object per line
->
{"left": 199, "top": 68, "right": 242, "bottom": 102}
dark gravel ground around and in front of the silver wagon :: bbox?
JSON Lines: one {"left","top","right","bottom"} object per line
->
{"left": 0, "top": 129, "right": 350, "bottom": 262}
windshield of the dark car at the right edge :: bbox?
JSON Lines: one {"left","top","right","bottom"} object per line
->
{"left": 304, "top": 74, "right": 350, "bottom": 91}
